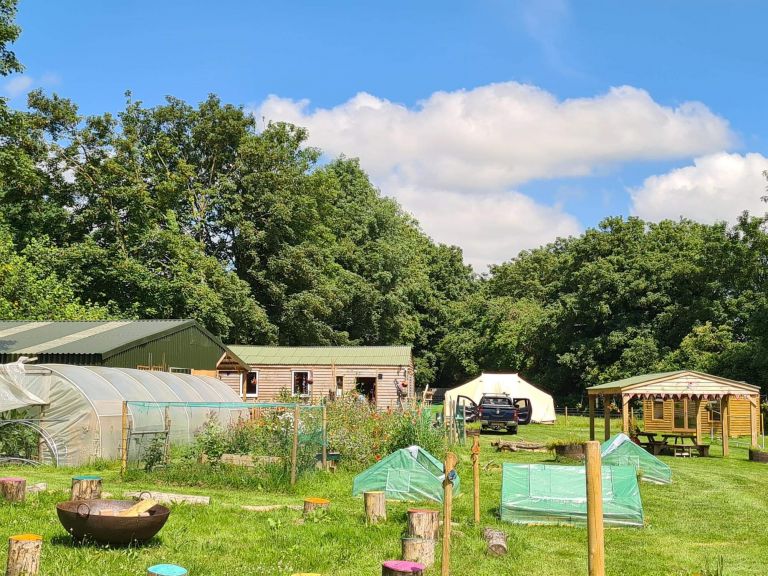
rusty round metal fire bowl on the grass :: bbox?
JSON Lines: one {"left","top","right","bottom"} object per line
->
{"left": 56, "top": 500, "right": 171, "bottom": 545}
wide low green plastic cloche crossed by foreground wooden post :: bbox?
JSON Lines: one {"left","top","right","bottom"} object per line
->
{"left": 500, "top": 464, "right": 643, "bottom": 527}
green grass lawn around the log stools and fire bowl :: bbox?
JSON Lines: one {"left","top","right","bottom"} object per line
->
{"left": 0, "top": 417, "right": 768, "bottom": 576}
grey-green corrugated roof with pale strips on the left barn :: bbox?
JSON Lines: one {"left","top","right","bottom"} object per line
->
{"left": 0, "top": 320, "right": 201, "bottom": 357}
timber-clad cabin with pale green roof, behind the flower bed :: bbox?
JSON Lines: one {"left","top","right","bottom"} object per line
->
{"left": 217, "top": 345, "right": 414, "bottom": 409}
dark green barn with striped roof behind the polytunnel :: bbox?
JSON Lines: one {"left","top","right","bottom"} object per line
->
{"left": 0, "top": 320, "right": 228, "bottom": 372}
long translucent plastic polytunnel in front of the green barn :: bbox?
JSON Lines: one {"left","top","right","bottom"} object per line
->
{"left": 0, "top": 364, "right": 247, "bottom": 466}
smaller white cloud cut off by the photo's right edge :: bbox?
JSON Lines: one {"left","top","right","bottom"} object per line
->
{"left": 630, "top": 152, "right": 768, "bottom": 222}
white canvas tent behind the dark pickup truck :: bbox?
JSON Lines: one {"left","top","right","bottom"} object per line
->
{"left": 445, "top": 372, "right": 555, "bottom": 424}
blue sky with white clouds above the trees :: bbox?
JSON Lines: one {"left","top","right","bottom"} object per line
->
{"left": 7, "top": 0, "right": 768, "bottom": 271}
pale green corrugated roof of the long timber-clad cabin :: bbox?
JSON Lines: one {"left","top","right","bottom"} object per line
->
{"left": 228, "top": 345, "right": 411, "bottom": 366}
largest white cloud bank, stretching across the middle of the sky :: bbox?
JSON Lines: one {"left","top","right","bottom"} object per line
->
{"left": 253, "top": 82, "right": 735, "bottom": 269}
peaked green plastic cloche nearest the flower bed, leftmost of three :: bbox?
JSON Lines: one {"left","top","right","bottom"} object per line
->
{"left": 352, "top": 446, "right": 460, "bottom": 502}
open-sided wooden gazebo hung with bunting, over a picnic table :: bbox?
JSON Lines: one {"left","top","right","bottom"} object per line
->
{"left": 587, "top": 370, "right": 760, "bottom": 455}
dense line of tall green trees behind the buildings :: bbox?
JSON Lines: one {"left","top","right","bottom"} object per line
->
{"left": 0, "top": 0, "right": 768, "bottom": 396}
